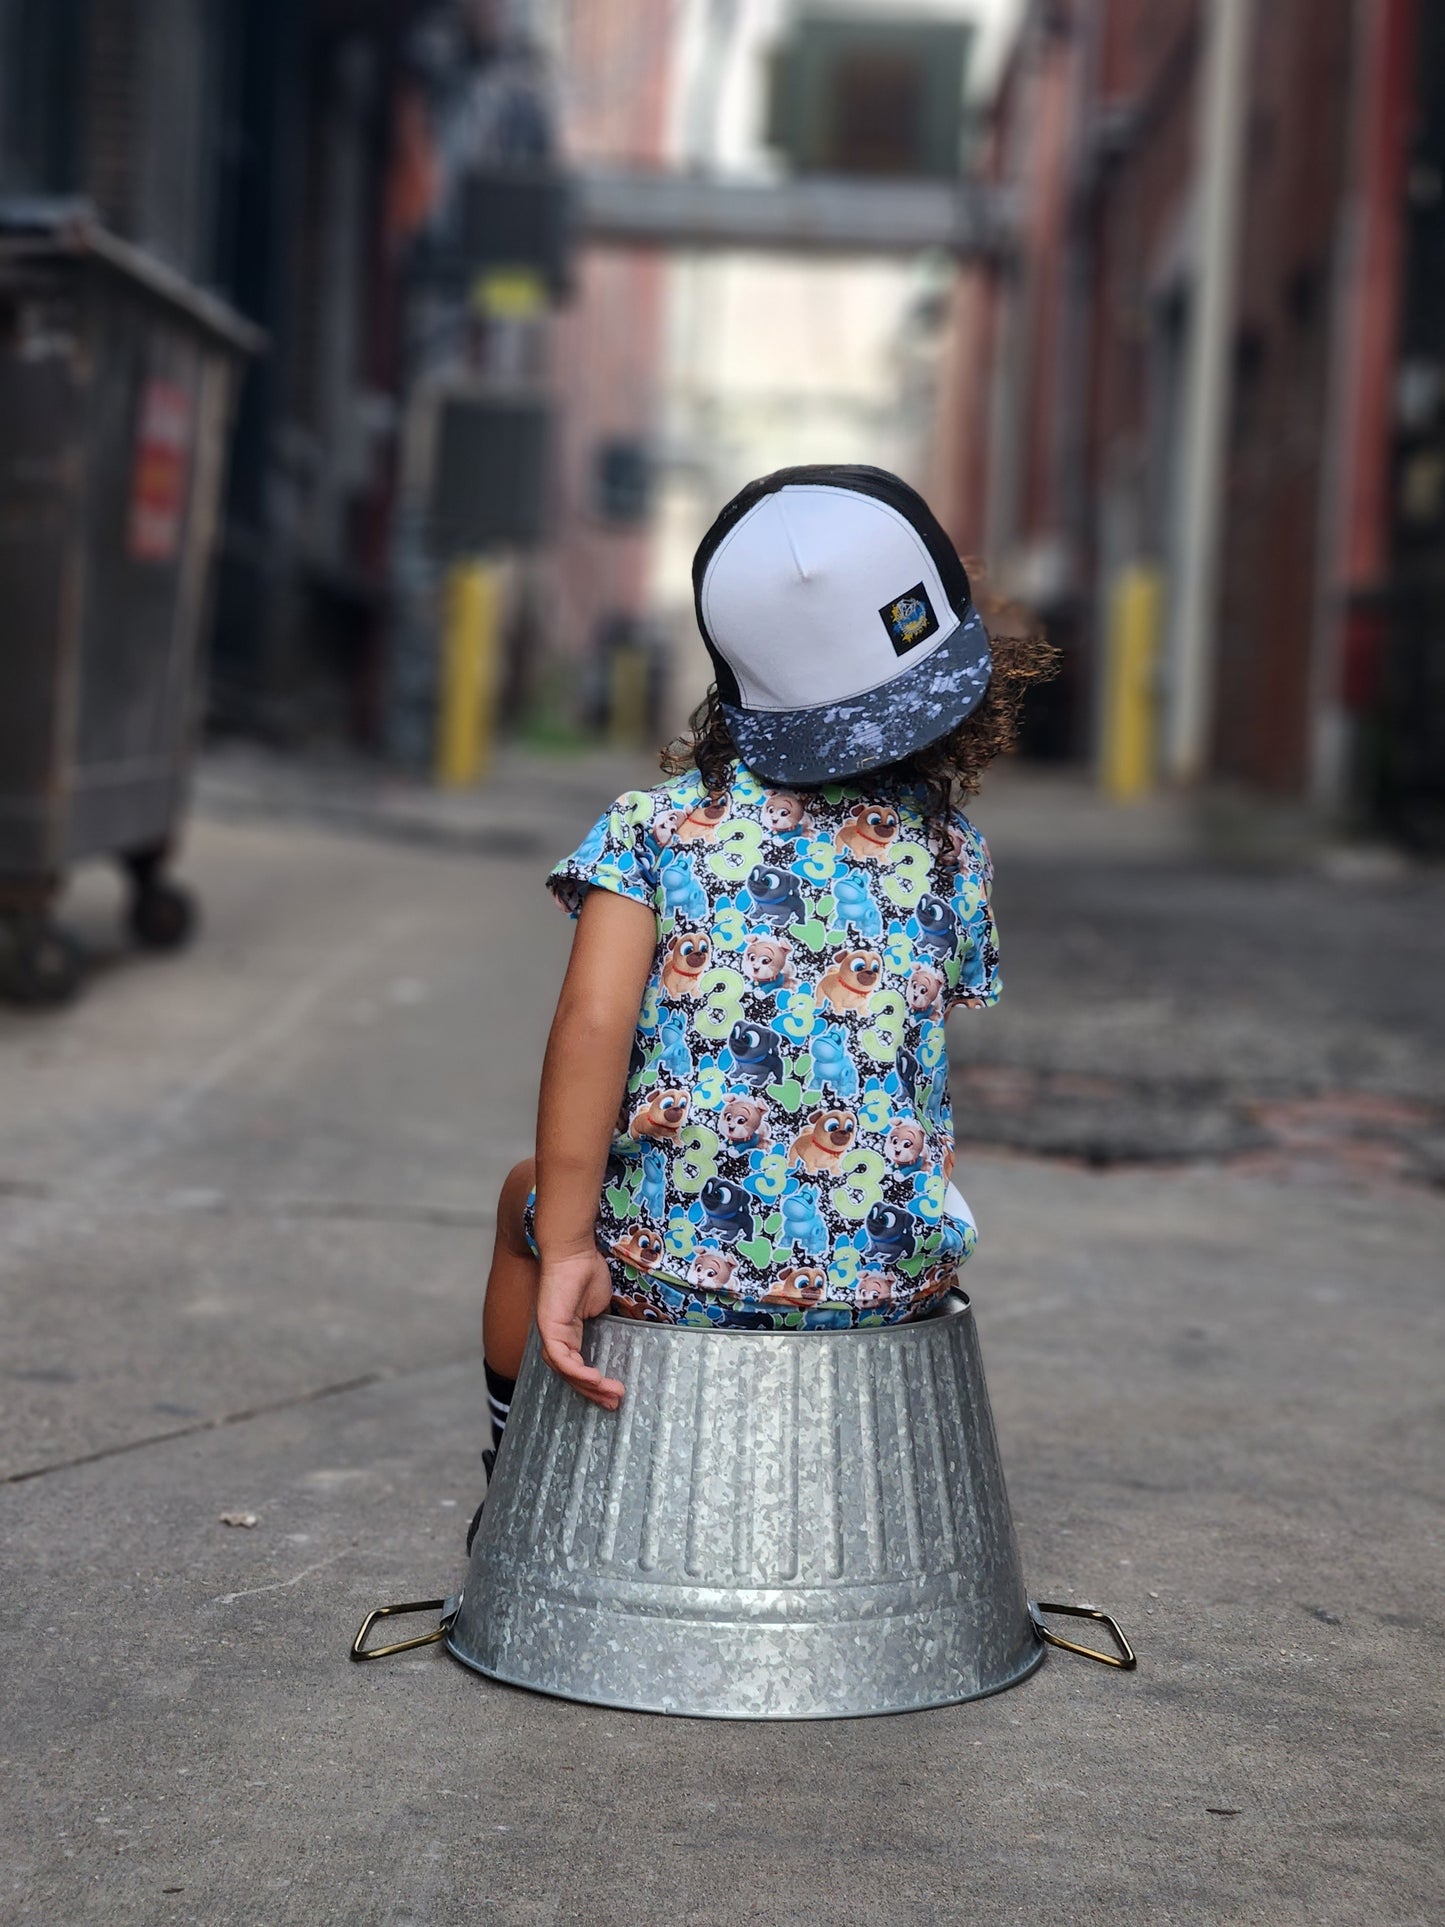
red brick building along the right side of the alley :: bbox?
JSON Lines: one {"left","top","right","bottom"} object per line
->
{"left": 948, "top": 0, "right": 1445, "bottom": 828}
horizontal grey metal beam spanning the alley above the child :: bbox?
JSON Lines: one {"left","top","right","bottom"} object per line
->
{"left": 574, "top": 170, "right": 1013, "bottom": 254}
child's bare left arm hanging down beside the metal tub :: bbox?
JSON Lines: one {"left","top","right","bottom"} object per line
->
{"left": 536, "top": 890, "right": 657, "bottom": 1411}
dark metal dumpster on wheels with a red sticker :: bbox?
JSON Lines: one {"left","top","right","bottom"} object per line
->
{"left": 0, "top": 202, "right": 262, "bottom": 1004}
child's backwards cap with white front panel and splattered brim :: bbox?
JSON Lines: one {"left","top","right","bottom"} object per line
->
{"left": 692, "top": 466, "right": 988, "bottom": 784}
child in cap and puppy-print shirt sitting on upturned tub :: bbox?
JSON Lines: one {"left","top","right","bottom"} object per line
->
{"left": 484, "top": 466, "right": 1052, "bottom": 1503}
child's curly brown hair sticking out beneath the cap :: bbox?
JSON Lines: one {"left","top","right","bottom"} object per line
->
{"left": 661, "top": 563, "right": 1060, "bottom": 840}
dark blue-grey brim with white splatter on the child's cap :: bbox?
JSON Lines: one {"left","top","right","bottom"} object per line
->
{"left": 723, "top": 607, "right": 990, "bottom": 786}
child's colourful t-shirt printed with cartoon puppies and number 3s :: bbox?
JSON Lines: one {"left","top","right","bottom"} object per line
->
{"left": 547, "top": 763, "right": 998, "bottom": 1328}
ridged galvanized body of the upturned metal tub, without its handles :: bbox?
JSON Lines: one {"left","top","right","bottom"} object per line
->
{"left": 447, "top": 1299, "right": 1042, "bottom": 1719}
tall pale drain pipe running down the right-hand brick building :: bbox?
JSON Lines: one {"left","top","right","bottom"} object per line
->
{"left": 1164, "top": 0, "right": 1254, "bottom": 782}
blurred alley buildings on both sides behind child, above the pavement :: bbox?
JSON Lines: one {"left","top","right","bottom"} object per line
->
{"left": 0, "top": 0, "right": 1445, "bottom": 842}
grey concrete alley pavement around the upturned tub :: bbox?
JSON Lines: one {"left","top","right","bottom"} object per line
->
{"left": 0, "top": 767, "right": 1445, "bottom": 1927}
